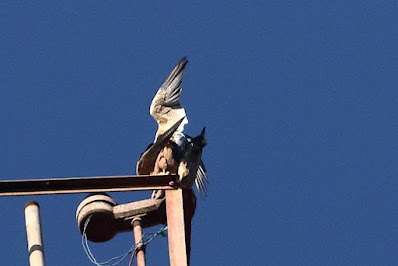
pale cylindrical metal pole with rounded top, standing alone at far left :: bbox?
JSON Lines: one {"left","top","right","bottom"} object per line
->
{"left": 25, "top": 201, "right": 45, "bottom": 266}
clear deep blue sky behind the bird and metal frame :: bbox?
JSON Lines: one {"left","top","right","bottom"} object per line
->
{"left": 0, "top": 0, "right": 398, "bottom": 266}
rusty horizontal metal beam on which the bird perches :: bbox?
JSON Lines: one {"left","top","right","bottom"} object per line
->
{"left": 0, "top": 175, "right": 177, "bottom": 196}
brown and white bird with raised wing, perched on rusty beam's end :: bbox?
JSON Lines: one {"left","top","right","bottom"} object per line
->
{"left": 137, "top": 57, "right": 207, "bottom": 198}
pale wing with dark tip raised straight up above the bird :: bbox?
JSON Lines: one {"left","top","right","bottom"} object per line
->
{"left": 149, "top": 57, "right": 188, "bottom": 136}
